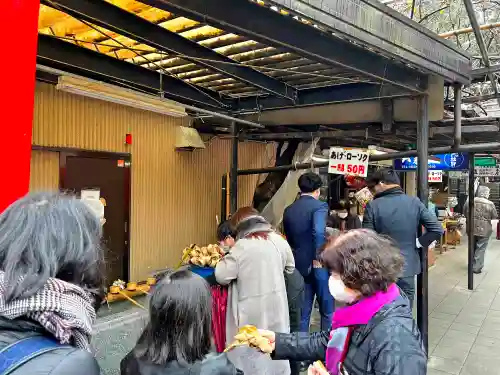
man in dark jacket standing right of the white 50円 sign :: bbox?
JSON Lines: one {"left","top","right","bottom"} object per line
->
{"left": 363, "top": 168, "right": 443, "bottom": 306}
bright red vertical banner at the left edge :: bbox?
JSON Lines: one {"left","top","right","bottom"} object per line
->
{"left": 0, "top": 0, "right": 40, "bottom": 212}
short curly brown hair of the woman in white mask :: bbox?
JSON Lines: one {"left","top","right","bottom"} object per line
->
{"left": 318, "top": 229, "right": 404, "bottom": 296}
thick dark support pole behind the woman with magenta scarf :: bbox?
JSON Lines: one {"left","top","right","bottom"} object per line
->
{"left": 417, "top": 96, "right": 429, "bottom": 352}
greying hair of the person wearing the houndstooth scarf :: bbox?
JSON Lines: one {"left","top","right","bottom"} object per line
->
{"left": 0, "top": 193, "right": 104, "bottom": 301}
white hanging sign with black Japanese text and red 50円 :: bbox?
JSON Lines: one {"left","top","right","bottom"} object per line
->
{"left": 328, "top": 147, "right": 370, "bottom": 177}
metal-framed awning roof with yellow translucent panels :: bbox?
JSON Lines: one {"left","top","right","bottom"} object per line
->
{"left": 38, "top": 0, "right": 470, "bottom": 120}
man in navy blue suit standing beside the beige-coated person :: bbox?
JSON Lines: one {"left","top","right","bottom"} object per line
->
{"left": 283, "top": 173, "right": 334, "bottom": 332}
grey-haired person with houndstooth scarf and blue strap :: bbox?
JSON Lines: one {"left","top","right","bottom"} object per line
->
{"left": 0, "top": 193, "right": 104, "bottom": 375}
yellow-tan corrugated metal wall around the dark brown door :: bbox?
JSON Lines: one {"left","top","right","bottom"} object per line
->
{"left": 31, "top": 83, "right": 274, "bottom": 280}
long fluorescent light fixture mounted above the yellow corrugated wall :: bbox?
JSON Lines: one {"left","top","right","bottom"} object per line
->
{"left": 56, "top": 76, "right": 187, "bottom": 117}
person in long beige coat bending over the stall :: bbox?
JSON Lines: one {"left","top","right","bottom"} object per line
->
{"left": 215, "top": 207, "right": 295, "bottom": 375}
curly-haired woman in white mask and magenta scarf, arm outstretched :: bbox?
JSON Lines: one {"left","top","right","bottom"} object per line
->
{"left": 261, "top": 229, "right": 427, "bottom": 375}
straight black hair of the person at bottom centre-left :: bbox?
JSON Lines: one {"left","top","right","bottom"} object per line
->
{"left": 134, "top": 268, "right": 212, "bottom": 365}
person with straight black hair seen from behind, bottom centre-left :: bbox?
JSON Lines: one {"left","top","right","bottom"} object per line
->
{"left": 120, "top": 268, "right": 243, "bottom": 375}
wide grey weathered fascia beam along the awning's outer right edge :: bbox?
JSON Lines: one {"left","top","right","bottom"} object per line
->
{"left": 270, "top": 0, "right": 471, "bottom": 84}
